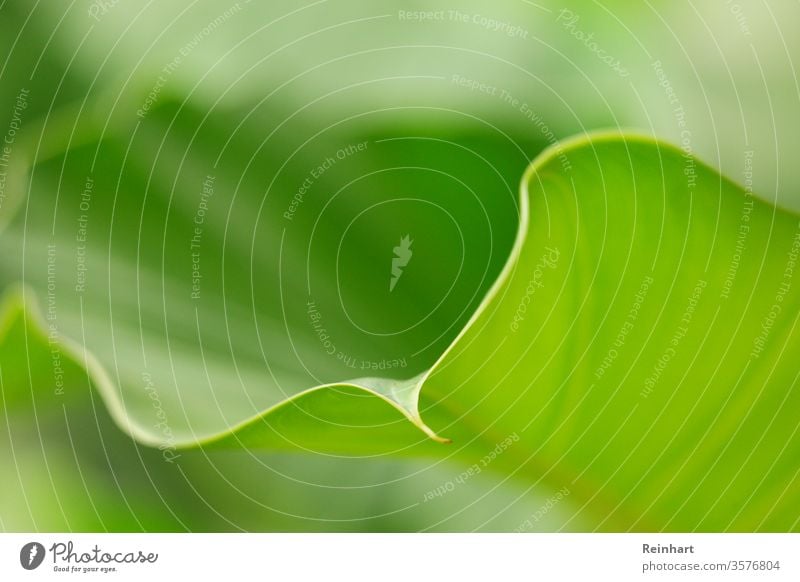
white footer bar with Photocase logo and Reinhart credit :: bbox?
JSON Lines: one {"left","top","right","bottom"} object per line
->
{"left": 0, "top": 534, "right": 800, "bottom": 582}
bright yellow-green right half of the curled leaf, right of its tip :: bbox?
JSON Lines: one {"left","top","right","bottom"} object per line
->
{"left": 423, "top": 134, "right": 800, "bottom": 531}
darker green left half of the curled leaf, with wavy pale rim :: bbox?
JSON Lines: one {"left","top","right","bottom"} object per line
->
{"left": 2, "top": 97, "right": 540, "bottom": 452}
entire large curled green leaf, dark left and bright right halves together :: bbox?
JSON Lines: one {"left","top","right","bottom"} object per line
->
{"left": 0, "top": 89, "right": 800, "bottom": 531}
